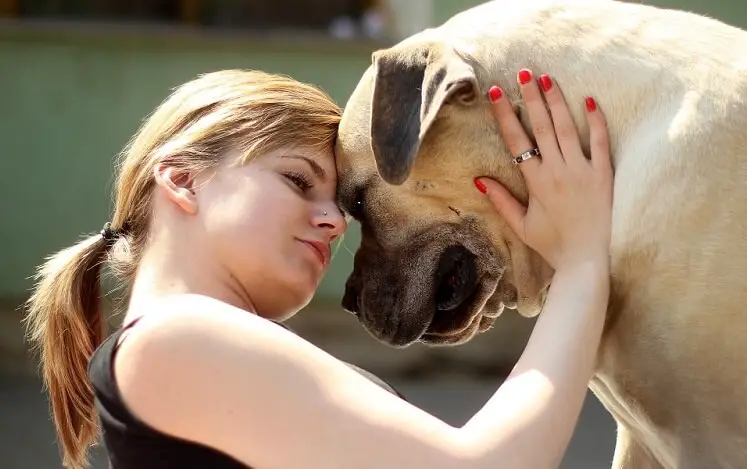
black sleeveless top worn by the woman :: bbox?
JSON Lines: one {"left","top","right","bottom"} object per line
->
{"left": 88, "top": 319, "right": 404, "bottom": 469}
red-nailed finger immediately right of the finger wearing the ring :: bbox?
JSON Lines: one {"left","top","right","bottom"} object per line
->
{"left": 517, "top": 69, "right": 563, "bottom": 165}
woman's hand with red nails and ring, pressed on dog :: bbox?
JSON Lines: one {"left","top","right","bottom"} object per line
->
{"left": 475, "top": 70, "right": 613, "bottom": 270}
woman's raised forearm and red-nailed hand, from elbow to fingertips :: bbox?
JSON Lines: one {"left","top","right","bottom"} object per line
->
{"left": 465, "top": 70, "right": 613, "bottom": 468}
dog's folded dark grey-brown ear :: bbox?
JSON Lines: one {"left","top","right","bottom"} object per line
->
{"left": 370, "top": 47, "right": 480, "bottom": 185}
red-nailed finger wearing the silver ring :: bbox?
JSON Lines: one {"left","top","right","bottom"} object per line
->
{"left": 488, "top": 86, "right": 540, "bottom": 176}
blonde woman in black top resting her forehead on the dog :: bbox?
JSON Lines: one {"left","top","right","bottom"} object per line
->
{"left": 28, "top": 71, "right": 612, "bottom": 469}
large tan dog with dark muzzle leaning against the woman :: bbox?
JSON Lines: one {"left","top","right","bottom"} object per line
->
{"left": 337, "top": 0, "right": 747, "bottom": 469}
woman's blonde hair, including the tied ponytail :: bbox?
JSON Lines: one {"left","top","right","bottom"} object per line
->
{"left": 25, "top": 70, "right": 341, "bottom": 469}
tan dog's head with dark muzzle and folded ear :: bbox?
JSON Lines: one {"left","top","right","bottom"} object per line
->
{"left": 336, "top": 36, "right": 548, "bottom": 346}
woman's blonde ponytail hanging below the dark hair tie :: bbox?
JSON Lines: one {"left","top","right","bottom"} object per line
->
{"left": 25, "top": 232, "right": 109, "bottom": 469}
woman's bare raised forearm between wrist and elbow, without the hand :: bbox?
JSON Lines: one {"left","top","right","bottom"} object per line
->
{"left": 462, "top": 260, "right": 609, "bottom": 468}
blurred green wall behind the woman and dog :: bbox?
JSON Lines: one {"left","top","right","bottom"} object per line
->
{"left": 0, "top": 0, "right": 747, "bottom": 302}
